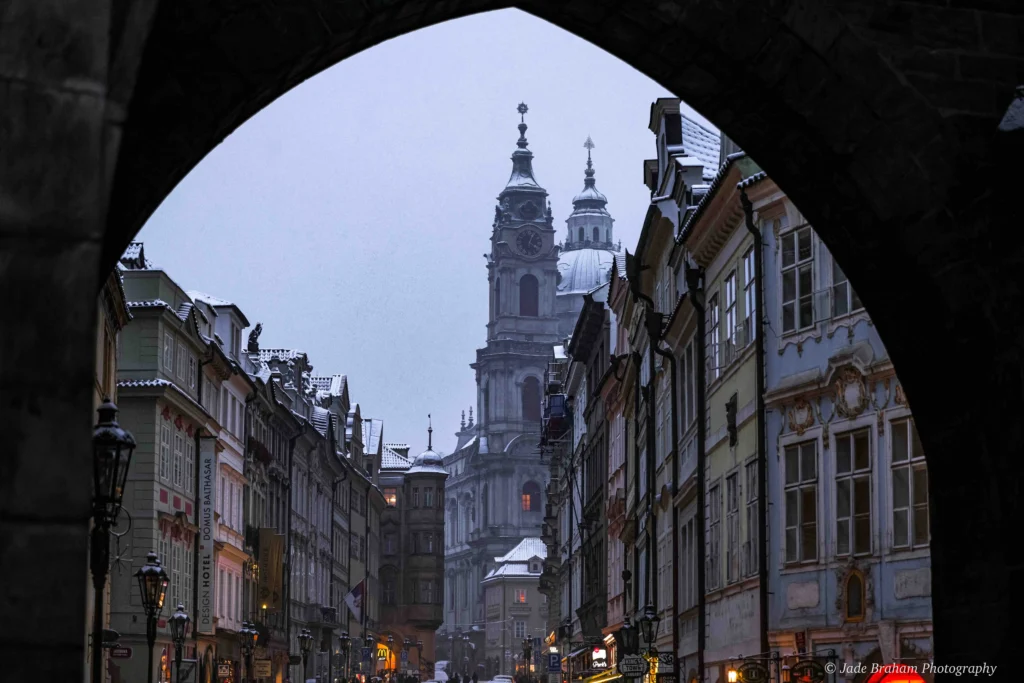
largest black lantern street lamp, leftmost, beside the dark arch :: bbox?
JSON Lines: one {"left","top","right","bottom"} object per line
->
{"left": 89, "top": 396, "right": 135, "bottom": 683}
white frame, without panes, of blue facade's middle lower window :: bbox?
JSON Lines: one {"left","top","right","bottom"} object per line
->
{"left": 829, "top": 418, "right": 876, "bottom": 557}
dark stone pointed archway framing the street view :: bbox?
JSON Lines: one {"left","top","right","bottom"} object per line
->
{"left": 0, "top": 0, "right": 1024, "bottom": 680}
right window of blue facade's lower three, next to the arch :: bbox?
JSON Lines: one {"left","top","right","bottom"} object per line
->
{"left": 891, "top": 419, "right": 931, "bottom": 548}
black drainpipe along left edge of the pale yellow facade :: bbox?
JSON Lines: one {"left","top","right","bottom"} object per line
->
{"left": 686, "top": 262, "right": 708, "bottom": 683}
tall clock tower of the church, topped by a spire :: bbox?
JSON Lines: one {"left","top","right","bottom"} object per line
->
{"left": 472, "top": 103, "right": 559, "bottom": 458}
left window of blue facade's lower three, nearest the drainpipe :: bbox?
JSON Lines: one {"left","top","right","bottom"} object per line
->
{"left": 785, "top": 441, "right": 818, "bottom": 562}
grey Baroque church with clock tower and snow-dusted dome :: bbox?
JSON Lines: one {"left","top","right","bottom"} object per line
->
{"left": 438, "top": 103, "right": 621, "bottom": 655}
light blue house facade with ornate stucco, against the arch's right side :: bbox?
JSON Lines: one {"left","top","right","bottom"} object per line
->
{"left": 740, "top": 173, "right": 933, "bottom": 682}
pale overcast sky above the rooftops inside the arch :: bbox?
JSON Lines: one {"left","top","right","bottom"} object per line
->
{"left": 137, "top": 10, "right": 705, "bottom": 453}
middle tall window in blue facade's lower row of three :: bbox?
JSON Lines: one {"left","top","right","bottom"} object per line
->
{"left": 836, "top": 429, "right": 871, "bottom": 555}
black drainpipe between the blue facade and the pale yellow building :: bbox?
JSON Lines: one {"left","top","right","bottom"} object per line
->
{"left": 739, "top": 190, "right": 770, "bottom": 653}
